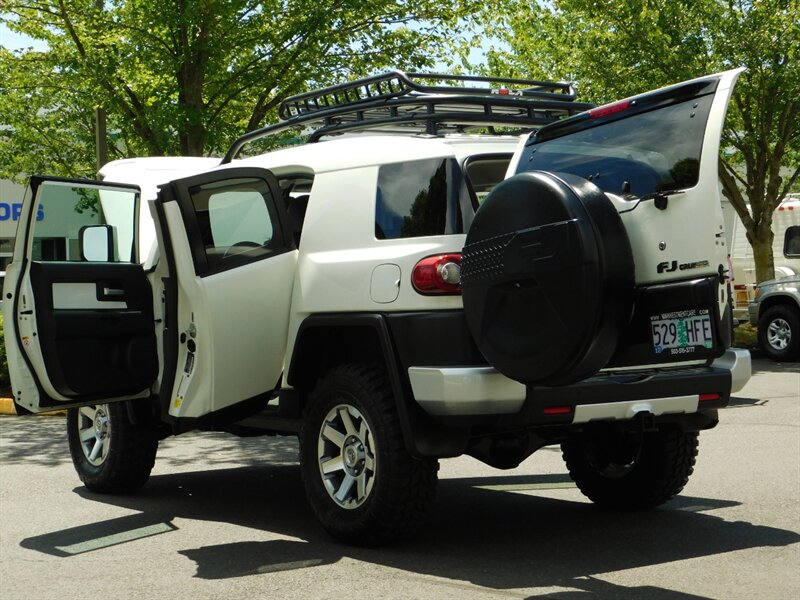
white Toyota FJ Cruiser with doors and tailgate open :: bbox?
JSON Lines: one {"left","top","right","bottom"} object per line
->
{"left": 3, "top": 71, "right": 750, "bottom": 544}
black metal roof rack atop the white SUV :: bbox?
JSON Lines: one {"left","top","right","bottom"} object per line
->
{"left": 222, "top": 71, "right": 594, "bottom": 164}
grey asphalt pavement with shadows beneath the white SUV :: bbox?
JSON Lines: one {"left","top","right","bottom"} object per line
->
{"left": 0, "top": 360, "right": 800, "bottom": 600}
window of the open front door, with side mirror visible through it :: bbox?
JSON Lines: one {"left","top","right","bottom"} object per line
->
{"left": 31, "top": 181, "right": 139, "bottom": 263}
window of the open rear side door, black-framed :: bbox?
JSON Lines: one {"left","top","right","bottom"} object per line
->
{"left": 189, "top": 179, "right": 284, "bottom": 274}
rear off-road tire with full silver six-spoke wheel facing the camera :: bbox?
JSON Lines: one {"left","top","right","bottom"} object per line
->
{"left": 300, "top": 364, "right": 439, "bottom": 546}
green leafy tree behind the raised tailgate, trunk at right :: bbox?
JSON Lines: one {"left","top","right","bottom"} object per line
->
{"left": 478, "top": 0, "right": 800, "bottom": 281}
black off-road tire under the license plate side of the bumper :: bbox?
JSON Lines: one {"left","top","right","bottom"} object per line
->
{"left": 561, "top": 427, "right": 698, "bottom": 510}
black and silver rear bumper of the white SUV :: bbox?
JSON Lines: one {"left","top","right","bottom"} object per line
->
{"left": 408, "top": 348, "right": 751, "bottom": 425}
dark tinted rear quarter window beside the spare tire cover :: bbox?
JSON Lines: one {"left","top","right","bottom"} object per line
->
{"left": 375, "top": 158, "right": 463, "bottom": 240}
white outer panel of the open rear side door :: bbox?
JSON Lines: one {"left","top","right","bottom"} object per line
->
{"left": 156, "top": 178, "right": 297, "bottom": 417}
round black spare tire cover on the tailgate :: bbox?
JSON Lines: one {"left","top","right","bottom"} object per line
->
{"left": 461, "top": 171, "right": 634, "bottom": 385}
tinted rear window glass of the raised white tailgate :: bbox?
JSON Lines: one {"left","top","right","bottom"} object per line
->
{"left": 519, "top": 94, "right": 714, "bottom": 197}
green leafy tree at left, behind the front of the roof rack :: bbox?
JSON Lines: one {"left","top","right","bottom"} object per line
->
{"left": 0, "top": 0, "right": 474, "bottom": 178}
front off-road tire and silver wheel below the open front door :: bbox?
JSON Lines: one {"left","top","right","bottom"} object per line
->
{"left": 67, "top": 402, "right": 158, "bottom": 494}
